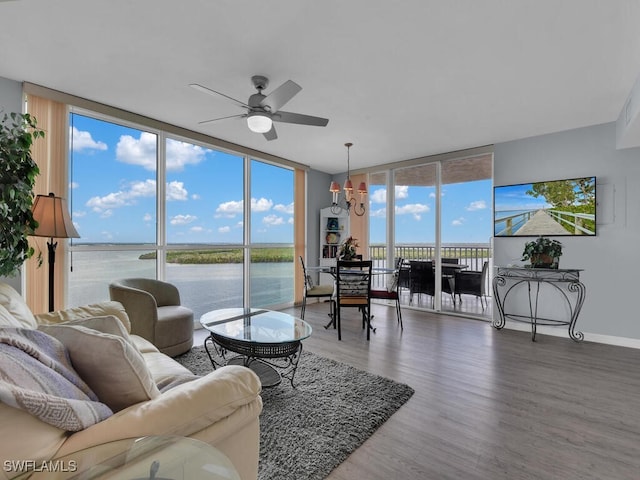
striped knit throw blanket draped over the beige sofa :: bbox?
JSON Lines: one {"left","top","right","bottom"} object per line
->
{"left": 0, "top": 327, "right": 113, "bottom": 432}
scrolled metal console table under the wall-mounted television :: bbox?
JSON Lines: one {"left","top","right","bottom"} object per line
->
{"left": 493, "top": 267, "right": 586, "bottom": 342}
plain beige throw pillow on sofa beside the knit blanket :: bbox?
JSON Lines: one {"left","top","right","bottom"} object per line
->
{"left": 40, "top": 325, "right": 160, "bottom": 412}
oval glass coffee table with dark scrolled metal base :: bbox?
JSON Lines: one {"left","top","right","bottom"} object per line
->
{"left": 200, "top": 308, "right": 312, "bottom": 387}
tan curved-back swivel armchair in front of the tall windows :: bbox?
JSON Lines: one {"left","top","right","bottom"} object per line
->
{"left": 109, "top": 278, "right": 193, "bottom": 357}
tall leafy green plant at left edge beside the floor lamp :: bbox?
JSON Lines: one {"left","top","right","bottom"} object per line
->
{"left": 0, "top": 113, "right": 44, "bottom": 276}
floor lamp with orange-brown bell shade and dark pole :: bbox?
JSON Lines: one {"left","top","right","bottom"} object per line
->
{"left": 32, "top": 193, "right": 80, "bottom": 312}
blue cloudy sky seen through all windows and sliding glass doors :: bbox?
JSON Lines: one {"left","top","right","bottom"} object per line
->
{"left": 69, "top": 114, "right": 493, "bottom": 244}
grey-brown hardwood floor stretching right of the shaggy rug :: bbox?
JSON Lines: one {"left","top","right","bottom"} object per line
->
{"left": 194, "top": 304, "right": 640, "bottom": 480}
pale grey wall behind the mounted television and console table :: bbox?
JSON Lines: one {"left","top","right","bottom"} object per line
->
{"left": 494, "top": 123, "right": 640, "bottom": 346}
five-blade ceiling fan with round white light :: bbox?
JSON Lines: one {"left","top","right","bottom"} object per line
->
{"left": 189, "top": 75, "right": 329, "bottom": 140}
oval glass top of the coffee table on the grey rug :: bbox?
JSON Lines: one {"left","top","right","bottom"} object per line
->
{"left": 200, "top": 308, "right": 312, "bottom": 343}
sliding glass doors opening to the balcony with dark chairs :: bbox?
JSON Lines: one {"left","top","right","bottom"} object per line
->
{"left": 369, "top": 154, "right": 493, "bottom": 318}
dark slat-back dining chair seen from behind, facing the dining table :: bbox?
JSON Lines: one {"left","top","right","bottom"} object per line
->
{"left": 335, "top": 260, "right": 375, "bottom": 340}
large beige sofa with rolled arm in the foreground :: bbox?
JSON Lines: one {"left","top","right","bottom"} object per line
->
{"left": 0, "top": 282, "right": 262, "bottom": 480}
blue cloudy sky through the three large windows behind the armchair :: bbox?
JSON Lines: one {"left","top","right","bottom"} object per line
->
{"left": 70, "top": 115, "right": 293, "bottom": 244}
